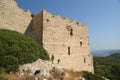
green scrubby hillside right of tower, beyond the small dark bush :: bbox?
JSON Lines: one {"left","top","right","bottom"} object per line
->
{"left": 94, "top": 57, "right": 120, "bottom": 80}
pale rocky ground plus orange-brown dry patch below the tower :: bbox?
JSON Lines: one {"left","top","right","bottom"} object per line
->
{"left": 19, "top": 59, "right": 82, "bottom": 80}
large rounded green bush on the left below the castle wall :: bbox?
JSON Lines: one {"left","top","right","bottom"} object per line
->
{"left": 0, "top": 30, "right": 49, "bottom": 72}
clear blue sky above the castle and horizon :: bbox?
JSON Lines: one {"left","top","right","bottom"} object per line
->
{"left": 16, "top": 0, "right": 120, "bottom": 50}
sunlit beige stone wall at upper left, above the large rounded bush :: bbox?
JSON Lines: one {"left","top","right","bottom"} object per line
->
{"left": 0, "top": 0, "right": 32, "bottom": 33}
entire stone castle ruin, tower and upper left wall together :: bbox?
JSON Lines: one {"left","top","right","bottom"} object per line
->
{"left": 0, "top": 0, "right": 94, "bottom": 72}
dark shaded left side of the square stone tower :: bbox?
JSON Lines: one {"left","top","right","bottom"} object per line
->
{"left": 25, "top": 12, "right": 43, "bottom": 45}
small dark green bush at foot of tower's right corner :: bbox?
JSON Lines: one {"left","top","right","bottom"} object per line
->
{"left": 83, "top": 71, "right": 105, "bottom": 80}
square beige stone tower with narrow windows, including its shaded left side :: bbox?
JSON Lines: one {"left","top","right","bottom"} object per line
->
{"left": 26, "top": 10, "right": 94, "bottom": 72}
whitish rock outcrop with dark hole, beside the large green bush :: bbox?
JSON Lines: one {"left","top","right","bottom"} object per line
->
{"left": 19, "top": 59, "right": 65, "bottom": 80}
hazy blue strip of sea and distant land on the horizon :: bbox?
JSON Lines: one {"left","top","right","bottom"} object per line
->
{"left": 91, "top": 50, "right": 120, "bottom": 57}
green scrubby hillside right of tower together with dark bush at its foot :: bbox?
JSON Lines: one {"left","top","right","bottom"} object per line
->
{"left": 83, "top": 54, "right": 120, "bottom": 80}
